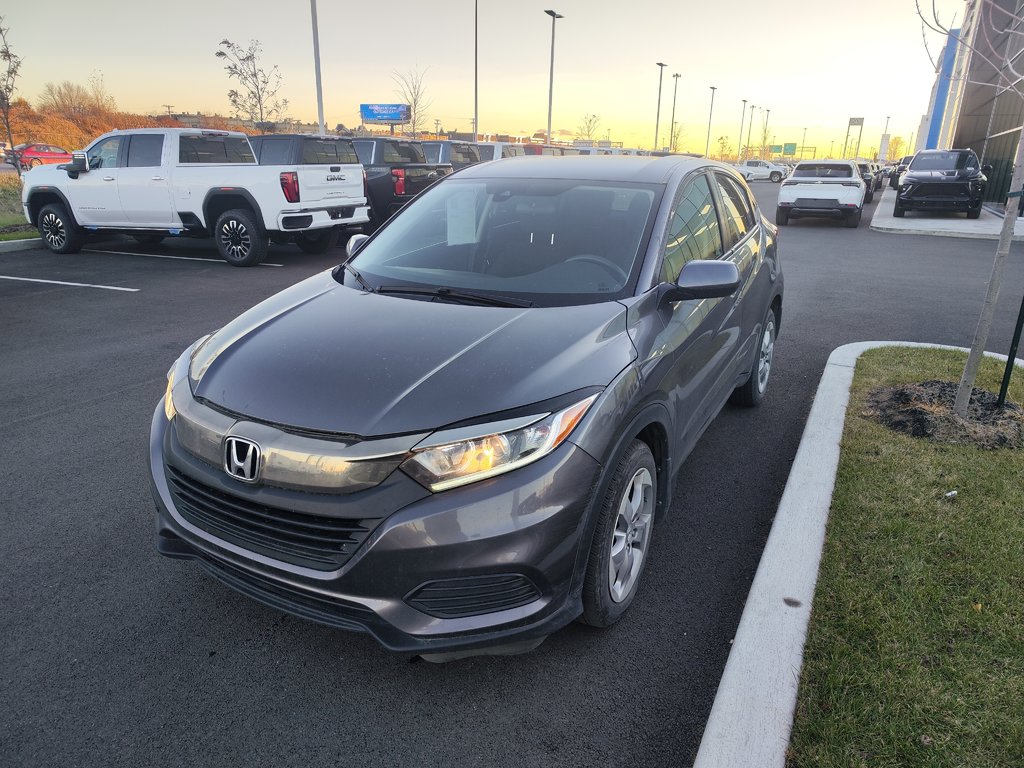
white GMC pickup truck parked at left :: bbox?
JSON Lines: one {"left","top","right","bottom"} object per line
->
{"left": 22, "top": 128, "right": 369, "bottom": 266}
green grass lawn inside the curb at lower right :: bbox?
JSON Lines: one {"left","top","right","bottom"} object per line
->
{"left": 787, "top": 347, "right": 1024, "bottom": 768}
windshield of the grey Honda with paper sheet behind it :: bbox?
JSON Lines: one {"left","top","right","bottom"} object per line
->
{"left": 346, "top": 178, "right": 663, "bottom": 306}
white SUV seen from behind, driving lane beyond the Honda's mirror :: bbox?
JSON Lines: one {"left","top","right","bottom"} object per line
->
{"left": 775, "top": 160, "right": 867, "bottom": 227}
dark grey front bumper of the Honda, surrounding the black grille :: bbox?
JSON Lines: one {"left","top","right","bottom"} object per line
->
{"left": 150, "top": 404, "right": 600, "bottom": 653}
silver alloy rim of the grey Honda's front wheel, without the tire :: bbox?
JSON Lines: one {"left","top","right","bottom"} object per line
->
{"left": 608, "top": 467, "right": 654, "bottom": 603}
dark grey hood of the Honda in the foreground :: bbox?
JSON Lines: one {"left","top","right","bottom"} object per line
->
{"left": 193, "top": 272, "right": 635, "bottom": 437}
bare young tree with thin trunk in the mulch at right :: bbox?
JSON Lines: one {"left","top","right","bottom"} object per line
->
{"left": 914, "top": 0, "right": 1024, "bottom": 419}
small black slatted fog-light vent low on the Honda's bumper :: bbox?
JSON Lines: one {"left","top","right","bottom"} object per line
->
{"left": 406, "top": 573, "right": 541, "bottom": 618}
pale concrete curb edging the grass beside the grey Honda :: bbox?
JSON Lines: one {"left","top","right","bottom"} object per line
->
{"left": 693, "top": 341, "right": 1024, "bottom": 768}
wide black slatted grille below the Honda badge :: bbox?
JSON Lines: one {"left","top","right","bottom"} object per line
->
{"left": 167, "top": 466, "right": 370, "bottom": 570}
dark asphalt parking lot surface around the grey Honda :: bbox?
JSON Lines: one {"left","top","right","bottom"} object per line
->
{"left": 0, "top": 182, "right": 1024, "bottom": 766}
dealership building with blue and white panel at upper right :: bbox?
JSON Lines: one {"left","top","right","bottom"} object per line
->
{"left": 913, "top": 0, "right": 1024, "bottom": 202}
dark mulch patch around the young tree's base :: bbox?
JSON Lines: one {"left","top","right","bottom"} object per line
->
{"left": 864, "top": 381, "right": 1024, "bottom": 449}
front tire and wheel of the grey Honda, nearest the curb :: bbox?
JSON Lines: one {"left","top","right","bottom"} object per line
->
{"left": 581, "top": 440, "right": 657, "bottom": 627}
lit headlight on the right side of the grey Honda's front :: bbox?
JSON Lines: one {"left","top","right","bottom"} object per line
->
{"left": 401, "top": 394, "right": 597, "bottom": 493}
